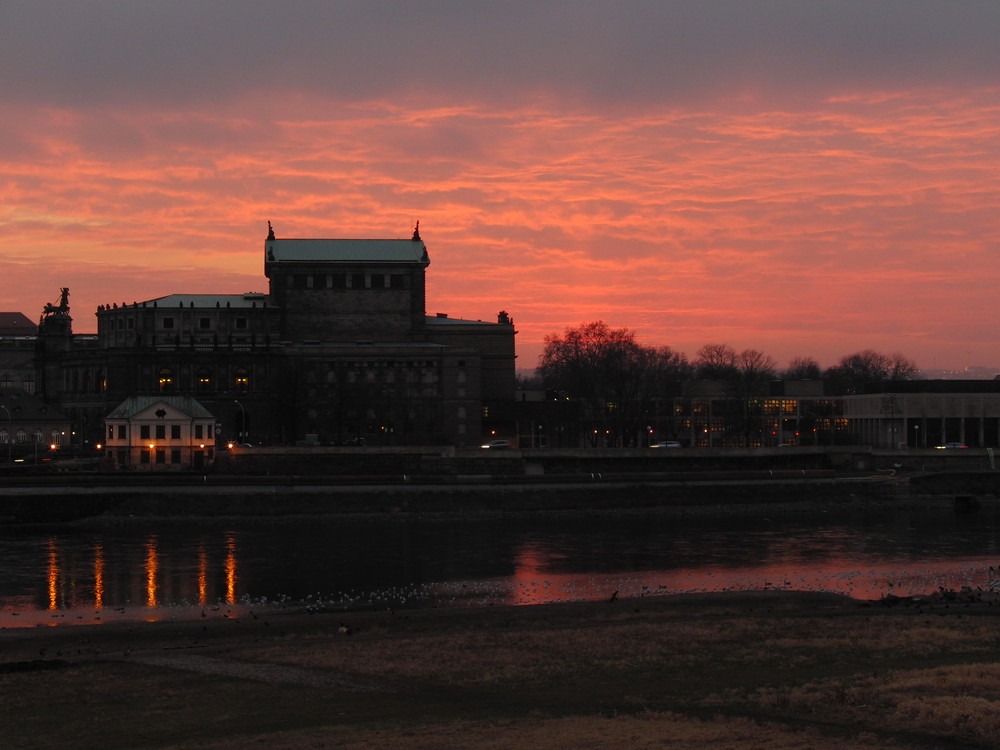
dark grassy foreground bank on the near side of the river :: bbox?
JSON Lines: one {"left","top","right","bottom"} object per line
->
{"left": 0, "top": 592, "right": 1000, "bottom": 750}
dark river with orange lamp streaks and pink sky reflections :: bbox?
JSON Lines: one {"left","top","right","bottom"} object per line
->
{"left": 0, "top": 506, "right": 1000, "bottom": 627}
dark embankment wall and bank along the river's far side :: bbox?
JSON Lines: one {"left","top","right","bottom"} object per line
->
{"left": 0, "top": 448, "right": 1000, "bottom": 523}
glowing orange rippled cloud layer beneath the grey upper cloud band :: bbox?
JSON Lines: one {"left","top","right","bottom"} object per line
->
{"left": 0, "top": 90, "right": 1000, "bottom": 374}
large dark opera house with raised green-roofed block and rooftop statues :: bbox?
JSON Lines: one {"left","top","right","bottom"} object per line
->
{"left": 34, "top": 232, "right": 515, "bottom": 446}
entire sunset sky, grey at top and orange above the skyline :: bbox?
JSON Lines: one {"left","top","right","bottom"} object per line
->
{"left": 0, "top": 0, "right": 1000, "bottom": 368}
